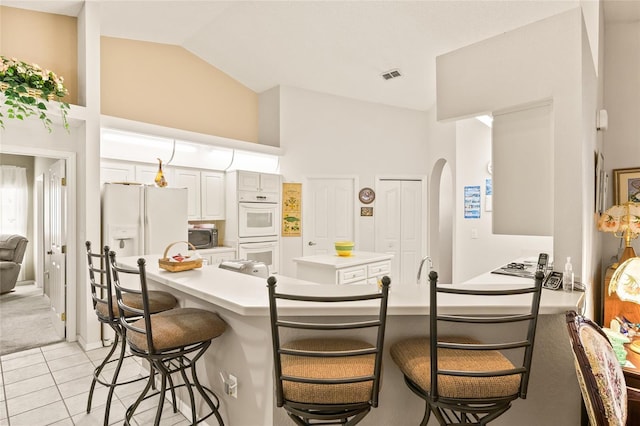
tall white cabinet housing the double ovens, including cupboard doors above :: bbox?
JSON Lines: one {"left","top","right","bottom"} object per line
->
{"left": 225, "top": 170, "right": 280, "bottom": 274}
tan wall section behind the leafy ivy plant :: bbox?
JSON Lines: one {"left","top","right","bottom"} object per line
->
{"left": 0, "top": 6, "right": 78, "bottom": 104}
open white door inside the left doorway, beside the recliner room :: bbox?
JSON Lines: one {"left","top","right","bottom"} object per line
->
{"left": 45, "top": 160, "right": 67, "bottom": 338}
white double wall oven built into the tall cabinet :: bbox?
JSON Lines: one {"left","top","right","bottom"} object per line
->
{"left": 238, "top": 193, "right": 280, "bottom": 274}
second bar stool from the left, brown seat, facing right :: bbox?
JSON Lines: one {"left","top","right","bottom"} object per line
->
{"left": 109, "top": 252, "right": 227, "bottom": 425}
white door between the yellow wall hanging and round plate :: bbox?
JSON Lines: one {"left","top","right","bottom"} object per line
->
{"left": 302, "top": 178, "right": 358, "bottom": 256}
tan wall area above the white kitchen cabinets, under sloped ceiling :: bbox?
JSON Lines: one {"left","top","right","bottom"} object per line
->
{"left": 100, "top": 37, "right": 258, "bottom": 142}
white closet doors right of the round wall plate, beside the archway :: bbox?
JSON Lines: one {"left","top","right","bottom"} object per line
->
{"left": 374, "top": 179, "right": 426, "bottom": 284}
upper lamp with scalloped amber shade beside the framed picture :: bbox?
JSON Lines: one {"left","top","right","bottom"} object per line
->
{"left": 598, "top": 202, "right": 640, "bottom": 268}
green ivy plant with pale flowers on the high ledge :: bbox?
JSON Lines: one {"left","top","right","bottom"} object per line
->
{"left": 0, "top": 56, "right": 70, "bottom": 133}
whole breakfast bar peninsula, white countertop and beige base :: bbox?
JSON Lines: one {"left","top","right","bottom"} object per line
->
{"left": 118, "top": 256, "right": 580, "bottom": 426}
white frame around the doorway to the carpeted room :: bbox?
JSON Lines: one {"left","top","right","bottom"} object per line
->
{"left": 0, "top": 143, "right": 78, "bottom": 342}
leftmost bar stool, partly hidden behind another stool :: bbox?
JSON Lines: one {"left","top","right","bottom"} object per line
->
{"left": 85, "top": 241, "right": 178, "bottom": 425}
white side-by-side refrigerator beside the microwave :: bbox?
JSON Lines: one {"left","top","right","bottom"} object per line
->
{"left": 101, "top": 183, "right": 189, "bottom": 257}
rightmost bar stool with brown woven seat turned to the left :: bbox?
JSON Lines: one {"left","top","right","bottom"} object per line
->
{"left": 390, "top": 271, "right": 543, "bottom": 426}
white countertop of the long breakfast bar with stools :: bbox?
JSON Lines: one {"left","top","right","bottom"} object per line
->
{"left": 118, "top": 255, "right": 583, "bottom": 316}
